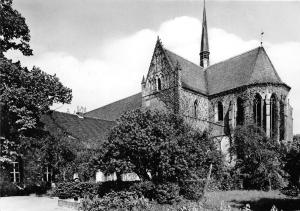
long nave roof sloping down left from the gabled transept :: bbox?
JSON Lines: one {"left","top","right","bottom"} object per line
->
{"left": 84, "top": 93, "right": 142, "bottom": 121}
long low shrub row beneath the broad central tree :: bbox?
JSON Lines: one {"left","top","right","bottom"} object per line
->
{"left": 53, "top": 181, "right": 203, "bottom": 204}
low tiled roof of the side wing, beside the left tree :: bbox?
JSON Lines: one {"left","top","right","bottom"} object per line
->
{"left": 41, "top": 111, "right": 115, "bottom": 148}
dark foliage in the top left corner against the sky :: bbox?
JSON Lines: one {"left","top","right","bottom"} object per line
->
{"left": 0, "top": 0, "right": 32, "bottom": 58}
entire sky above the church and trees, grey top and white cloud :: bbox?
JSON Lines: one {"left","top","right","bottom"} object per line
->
{"left": 7, "top": 0, "right": 300, "bottom": 133}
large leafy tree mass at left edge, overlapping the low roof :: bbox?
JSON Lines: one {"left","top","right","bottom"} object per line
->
{"left": 0, "top": 58, "right": 72, "bottom": 164}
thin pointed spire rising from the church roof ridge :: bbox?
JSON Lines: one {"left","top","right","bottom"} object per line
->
{"left": 200, "top": 0, "right": 209, "bottom": 67}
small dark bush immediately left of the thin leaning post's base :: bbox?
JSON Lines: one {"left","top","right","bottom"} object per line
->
{"left": 179, "top": 181, "right": 204, "bottom": 201}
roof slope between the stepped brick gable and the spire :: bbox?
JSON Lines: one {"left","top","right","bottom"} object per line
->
{"left": 165, "top": 49, "right": 207, "bottom": 94}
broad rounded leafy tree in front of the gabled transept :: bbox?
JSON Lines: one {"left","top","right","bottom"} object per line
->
{"left": 98, "top": 109, "right": 222, "bottom": 182}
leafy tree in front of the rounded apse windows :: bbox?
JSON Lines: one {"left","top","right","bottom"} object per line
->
{"left": 231, "top": 125, "right": 283, "bottom": 189}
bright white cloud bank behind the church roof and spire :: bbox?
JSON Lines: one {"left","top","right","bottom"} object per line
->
{"left": 5, "top": 16, "right": 300, "bottom": 133}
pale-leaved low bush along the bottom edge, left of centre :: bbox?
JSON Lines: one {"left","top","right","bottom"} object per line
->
{"left": 79, "top": 191, "right": 148, "bottom": 211}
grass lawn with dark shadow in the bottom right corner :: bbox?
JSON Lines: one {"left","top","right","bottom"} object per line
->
{"left": 205, "top": 191, "right": 300, "bottom": 211}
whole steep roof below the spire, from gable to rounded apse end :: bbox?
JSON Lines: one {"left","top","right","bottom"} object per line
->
{"left": 165, "top": 47, "right": 285, "bottom": 95}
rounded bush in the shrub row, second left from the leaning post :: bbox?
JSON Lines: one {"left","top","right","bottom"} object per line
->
{"left": 154, "top": 182, "right": 180, "bottom": 204}
